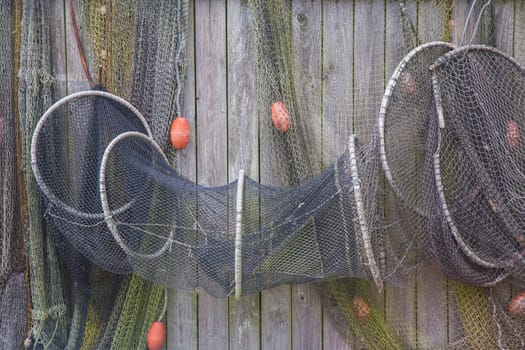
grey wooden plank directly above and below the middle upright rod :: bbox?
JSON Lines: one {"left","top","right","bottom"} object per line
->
{"left": 227, "top": 0, "right": 261, "bottom": 350}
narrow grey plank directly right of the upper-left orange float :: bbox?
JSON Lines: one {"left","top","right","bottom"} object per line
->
{"left": 166, "top": 3, "right": 198, "bottom": 350}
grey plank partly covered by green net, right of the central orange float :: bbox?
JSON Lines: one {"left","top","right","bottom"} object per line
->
{"left": 292, "top": 0, "right": 322, "bottom": 349}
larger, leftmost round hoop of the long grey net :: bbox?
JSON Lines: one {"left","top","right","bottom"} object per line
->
{"left": 31, "top": 90, "right": 153, "bottom": 219}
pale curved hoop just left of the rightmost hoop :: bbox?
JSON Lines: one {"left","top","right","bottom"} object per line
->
{"left": 377, "top": 41, "right": 456, "bottom": 217}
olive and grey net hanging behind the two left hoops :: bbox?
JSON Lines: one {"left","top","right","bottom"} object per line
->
{"left": 79, "top": 0, "right": 189, "bottom": 349}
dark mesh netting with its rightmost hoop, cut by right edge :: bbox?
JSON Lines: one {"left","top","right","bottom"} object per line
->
{"left": 433, "top": 46, "right": 525, "bottom": 284}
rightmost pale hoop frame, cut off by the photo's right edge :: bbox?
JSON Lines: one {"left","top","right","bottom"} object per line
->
{"left": 429, "top": 45, "right": 524, "bottom": 270}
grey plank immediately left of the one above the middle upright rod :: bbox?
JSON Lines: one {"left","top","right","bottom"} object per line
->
{"left": 195, "top": 0, "right": 228, "bottom": 350}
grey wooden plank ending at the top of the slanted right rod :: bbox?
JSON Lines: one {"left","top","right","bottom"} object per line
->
{"left": 321, "top": 1, "right": 354, "bottom": 350}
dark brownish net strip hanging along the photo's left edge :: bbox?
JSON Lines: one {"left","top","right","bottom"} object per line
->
{"left": 0, "top": 1, "right": 27, "bottom": 349}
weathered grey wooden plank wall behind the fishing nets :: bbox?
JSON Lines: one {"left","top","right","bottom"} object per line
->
{"left": 51, "top": 0, "right": 525, "bottom": 350}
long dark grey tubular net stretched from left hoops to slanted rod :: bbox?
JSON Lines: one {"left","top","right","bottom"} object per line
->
{"left": 33, "top": 92, "right": 388, "bottom": 296}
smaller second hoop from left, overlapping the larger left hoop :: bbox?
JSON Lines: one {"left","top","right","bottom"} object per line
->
{"left": 99, "top": 131, "right": 174, "bottom": 260}
